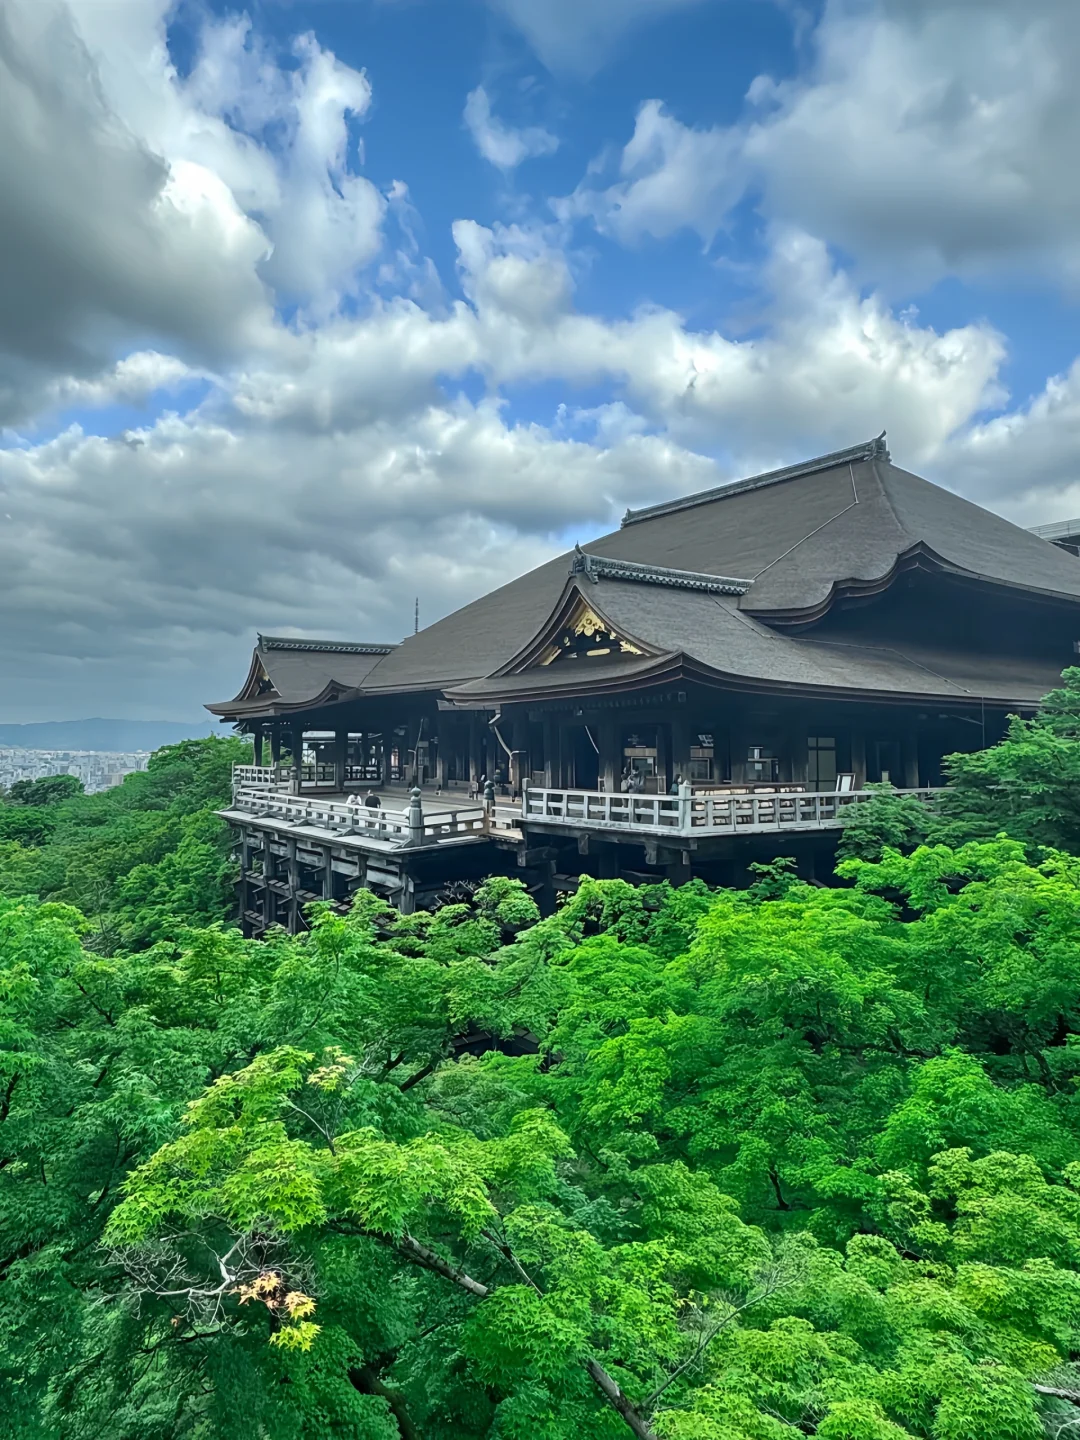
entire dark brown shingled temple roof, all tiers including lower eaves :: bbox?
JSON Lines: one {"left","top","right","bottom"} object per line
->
{"left": 209, "top": 436, "right": 1080, "bottom": 717}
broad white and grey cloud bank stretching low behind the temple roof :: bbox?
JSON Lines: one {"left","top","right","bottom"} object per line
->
{"left": 0, "top": 207, "right": 1025, "bottom": 707}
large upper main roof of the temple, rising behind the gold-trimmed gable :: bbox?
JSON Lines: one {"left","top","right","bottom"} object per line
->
{"left": 364, "top": 439, "right": 1080, "bottom": 690}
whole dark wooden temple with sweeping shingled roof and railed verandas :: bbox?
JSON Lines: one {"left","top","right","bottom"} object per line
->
{"left": 207, "top": 436, "right": 1080, "bottom": 933}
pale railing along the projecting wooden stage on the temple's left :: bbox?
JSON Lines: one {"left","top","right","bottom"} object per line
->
{"left": 233, "top": 789, "right": 487, "bottom": 847}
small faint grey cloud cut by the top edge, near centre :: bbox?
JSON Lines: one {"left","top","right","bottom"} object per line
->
{"left": 488, "top": 0, "right": 711, "bottom": 76}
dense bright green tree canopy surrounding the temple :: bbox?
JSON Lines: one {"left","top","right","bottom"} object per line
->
{"left": 0, "top": 670, "right": 1080, "bottom": 1440}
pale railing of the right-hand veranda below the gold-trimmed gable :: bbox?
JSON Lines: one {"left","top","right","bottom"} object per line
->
{"left": 521, "top": 789, "right": 937, "bottom": 835}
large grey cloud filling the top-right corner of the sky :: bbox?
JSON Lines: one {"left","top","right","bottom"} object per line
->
{"left": 564, "top": 0, "right": 1080, "bottom": 288}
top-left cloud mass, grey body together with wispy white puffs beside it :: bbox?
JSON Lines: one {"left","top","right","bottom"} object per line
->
{"left": 0, "top": 0, "right": 386, "bottom": 423}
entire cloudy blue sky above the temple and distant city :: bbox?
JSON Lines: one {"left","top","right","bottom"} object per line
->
{"left": 0, "top": 0, "right": 1080, "bottom": 721}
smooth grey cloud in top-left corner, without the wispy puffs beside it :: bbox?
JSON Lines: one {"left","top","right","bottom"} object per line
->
{"left": 0, "top": 0, "right": 269, "bottom": 422}
